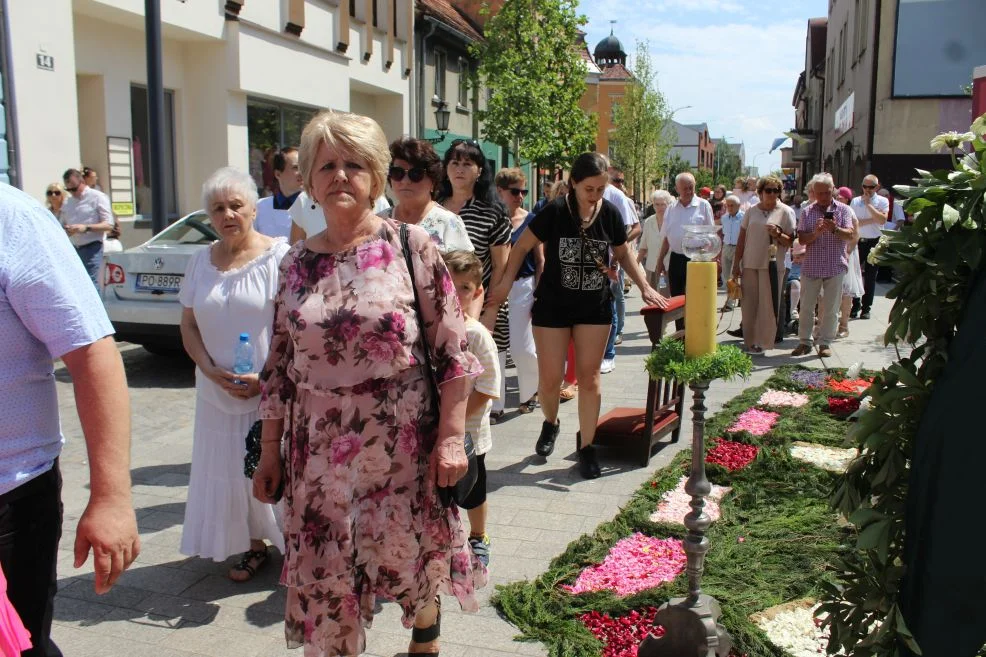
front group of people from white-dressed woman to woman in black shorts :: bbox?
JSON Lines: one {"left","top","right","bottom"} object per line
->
{"left": 163, "top": 112, "right": 666, "bottom": 655}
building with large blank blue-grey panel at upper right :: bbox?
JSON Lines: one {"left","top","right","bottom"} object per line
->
{"left": 821, "top": 0, "right": 972, "bottom": 191}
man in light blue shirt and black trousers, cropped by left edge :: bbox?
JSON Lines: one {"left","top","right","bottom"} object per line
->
{"left": 0, "top": 184, "right": 140, "bottom": 657}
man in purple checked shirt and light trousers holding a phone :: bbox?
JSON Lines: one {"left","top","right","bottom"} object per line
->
{"left": 791, "top": 173, "right": 855, "bottom": 358}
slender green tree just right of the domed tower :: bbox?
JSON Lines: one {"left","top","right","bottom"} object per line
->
{"left": 610, "top": 41, "right": 674, "bottom": 198}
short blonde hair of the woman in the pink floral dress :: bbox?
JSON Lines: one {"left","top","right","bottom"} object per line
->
{"left": 298, "top": 110, "right": 390, "bottom": 206}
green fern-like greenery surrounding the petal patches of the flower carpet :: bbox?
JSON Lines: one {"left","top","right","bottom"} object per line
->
{"left": 493, "top": 367, "right": 848, "bottom": 657}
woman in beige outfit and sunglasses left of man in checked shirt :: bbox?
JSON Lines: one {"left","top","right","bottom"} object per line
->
{"left": 732, "top": 176, "right": 797, "bottom": 354}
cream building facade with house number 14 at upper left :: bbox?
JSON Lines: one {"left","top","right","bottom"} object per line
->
{"left": 6, "top": 0, "right": 414, "bottom": 244}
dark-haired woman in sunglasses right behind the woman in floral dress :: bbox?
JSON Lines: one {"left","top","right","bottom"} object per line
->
{"left": 379, "top": 137, "right": 473, "bottom": 253}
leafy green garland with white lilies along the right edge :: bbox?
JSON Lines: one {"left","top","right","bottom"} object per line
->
{"left": 824, "top": 118, "right": 986, "bottom": 657}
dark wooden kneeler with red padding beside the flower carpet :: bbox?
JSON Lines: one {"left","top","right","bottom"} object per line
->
{"left": 594, "top": 296, "right": 685, "bottom": 467}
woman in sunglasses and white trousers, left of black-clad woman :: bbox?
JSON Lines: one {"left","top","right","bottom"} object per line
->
{"left": 495, "top": 169, "right": 544, "bottom": 414}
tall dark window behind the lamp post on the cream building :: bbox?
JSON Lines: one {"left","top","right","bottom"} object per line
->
{"left": 130, "top": 85, "right": 178, "bottom": 221}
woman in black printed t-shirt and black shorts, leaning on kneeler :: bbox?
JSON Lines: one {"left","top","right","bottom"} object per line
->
{"left": 487, "top": 153, "right": 667, "bottom": 479}
